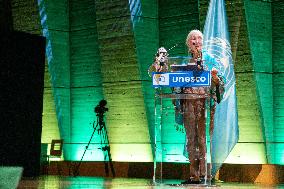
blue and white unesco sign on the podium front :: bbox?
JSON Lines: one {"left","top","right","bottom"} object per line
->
{"left": 152, "top": 71, "right": 211, "bottom": 87}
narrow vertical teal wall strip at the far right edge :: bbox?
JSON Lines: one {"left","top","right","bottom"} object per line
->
{"left": 268, "top": 0, "right": 284, "bottom": 164}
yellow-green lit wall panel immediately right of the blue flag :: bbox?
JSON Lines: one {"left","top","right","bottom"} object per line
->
{"left": 226, "top": 1, "right": 272, "bottom": 164}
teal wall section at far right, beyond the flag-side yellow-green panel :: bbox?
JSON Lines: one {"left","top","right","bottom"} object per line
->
{"left": 242, "top": 1, "right": 283, "bottom": 164}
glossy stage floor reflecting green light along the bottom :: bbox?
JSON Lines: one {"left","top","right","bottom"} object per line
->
{"left": 18, "top": 176, "right": 284, "bottom": 189}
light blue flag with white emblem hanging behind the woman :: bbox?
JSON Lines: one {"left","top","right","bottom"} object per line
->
{"left": 203, "top": 0, "right": 239, "bottom": 175}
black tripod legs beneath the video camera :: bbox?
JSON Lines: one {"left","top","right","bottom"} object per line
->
{"left": 73, "top": 113, "right": 115, "bottom": 177}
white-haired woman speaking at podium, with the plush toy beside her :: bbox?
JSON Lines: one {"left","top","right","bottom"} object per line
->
{"left": 153, "top": 30, "right": 224, "bottom": 184}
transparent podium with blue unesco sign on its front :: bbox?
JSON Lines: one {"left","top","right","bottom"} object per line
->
{"left": 152, "top": 58, "right": 211, "bottom": 185}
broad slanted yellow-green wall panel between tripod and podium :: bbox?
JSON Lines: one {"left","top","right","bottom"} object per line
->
{"left": 95, "top": 0, "right": 152, "bottom": 162}
